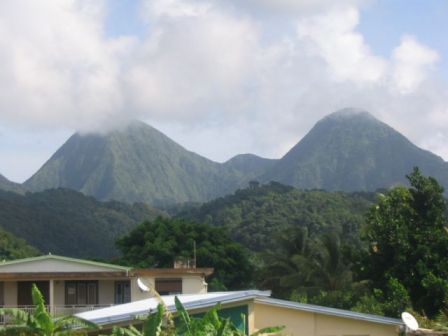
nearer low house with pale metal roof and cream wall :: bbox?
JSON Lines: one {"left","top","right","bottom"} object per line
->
{"left": 78, "top": 290, "right": 404, "bottom": 336}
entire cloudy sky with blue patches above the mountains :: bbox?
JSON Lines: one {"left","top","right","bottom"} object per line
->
{"left": 0, "top": 0, "right": 448, "bottom": 182}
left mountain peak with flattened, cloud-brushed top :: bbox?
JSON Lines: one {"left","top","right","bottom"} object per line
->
{"left": 25, "top": 122, "right": 240, "bottom": 205}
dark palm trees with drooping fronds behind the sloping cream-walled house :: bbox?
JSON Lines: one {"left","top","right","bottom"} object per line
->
{"left": 259, "top": 228, "right": 353, "bottom": 309}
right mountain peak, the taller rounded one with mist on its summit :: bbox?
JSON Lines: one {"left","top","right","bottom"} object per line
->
{"left": 260, "top": 109, "right": 448, "bottom": 191}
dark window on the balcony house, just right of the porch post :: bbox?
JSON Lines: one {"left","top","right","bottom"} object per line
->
{"left": 65, "top": 281, "right": 98, "bottom": 305}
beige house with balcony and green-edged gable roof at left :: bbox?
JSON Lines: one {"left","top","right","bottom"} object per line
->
{"left": 0, "top": 254, "right": 213, "bottom": 315}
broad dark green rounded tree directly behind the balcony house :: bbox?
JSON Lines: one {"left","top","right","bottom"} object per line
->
{"left": 117, "top": 217, "right": 253, "bottom": 289}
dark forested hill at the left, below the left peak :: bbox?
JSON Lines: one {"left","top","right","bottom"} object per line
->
{"left": 0, "top": 189, "right": 161, "bottom": 258}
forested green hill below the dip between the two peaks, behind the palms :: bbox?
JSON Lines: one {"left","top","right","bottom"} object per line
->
{"left": 176, "top": 182, "right": 375, "bottom": 251}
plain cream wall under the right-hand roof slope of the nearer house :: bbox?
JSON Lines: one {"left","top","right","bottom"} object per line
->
{"left": 249, "top": 303, "right": 398, "bottom": 336}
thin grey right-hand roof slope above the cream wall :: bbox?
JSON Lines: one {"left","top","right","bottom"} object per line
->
{"left": 255, "top": 297, "right": 404, "bottom": 326}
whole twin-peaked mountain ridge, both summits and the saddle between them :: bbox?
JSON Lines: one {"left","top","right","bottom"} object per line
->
{"left": 9, "top": 108, "right": 448, "bottom": 206}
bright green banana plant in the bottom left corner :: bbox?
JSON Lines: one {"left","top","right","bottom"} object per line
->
{"left": 0, "top": 284, "right": 98, "bottom": 336}
